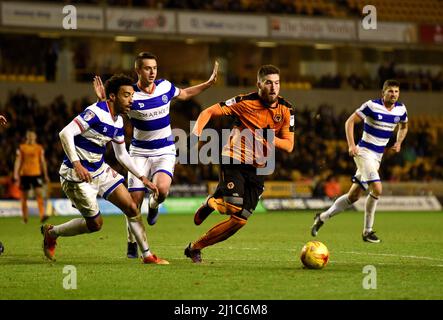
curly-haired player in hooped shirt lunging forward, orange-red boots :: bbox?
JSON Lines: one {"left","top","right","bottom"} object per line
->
{"left": 41, "top": 75, "right": 168, "bottom": 264}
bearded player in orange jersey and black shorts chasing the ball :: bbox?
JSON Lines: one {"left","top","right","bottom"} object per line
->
{"left": 185, "top": 65, "right": 294, "bottom": 263}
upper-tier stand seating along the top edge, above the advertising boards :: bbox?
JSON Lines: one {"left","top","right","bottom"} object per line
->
{"left": 16, "top": 0, "right": 443, "bottom": 23}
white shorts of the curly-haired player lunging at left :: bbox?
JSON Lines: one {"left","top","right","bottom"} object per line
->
{"left": 60, "top": 164, "right": 124, "bottom": 218}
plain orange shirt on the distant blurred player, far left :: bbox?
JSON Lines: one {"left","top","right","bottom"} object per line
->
{"left": 17, "top": 143, "right": 44, "bottom": 176}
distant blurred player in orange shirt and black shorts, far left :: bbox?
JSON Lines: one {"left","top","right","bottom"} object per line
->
{"left": 14, "top": 130, "right": 49, "bottom": 223}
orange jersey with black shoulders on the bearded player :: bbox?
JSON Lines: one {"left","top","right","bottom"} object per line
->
{"left": 219, "top": 92, "right": 294, "bottom": 167}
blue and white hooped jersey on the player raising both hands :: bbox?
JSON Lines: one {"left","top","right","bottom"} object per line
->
{"left": 129, "top": 79, "right": 180, "bottom": 157}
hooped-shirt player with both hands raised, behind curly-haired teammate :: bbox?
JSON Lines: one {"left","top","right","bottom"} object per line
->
{"left": 94, "top": 52, "right": 218, "bottom": 258}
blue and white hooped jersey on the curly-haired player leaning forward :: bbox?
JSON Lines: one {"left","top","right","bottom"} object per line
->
{"left": 59, "top": 101, "right": 125, "bottom": 181}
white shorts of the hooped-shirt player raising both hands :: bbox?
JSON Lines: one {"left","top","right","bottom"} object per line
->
{"left": 128, "top": 154, "right": 176, "bottom": 192}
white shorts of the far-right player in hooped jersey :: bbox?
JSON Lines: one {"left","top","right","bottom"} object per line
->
{"left": 352, "top": 148, "right": 380, "bottom": 190}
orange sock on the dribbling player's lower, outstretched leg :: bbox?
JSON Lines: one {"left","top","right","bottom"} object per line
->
{"left": 192, "top": 215, "right": 248, "bottom": 250}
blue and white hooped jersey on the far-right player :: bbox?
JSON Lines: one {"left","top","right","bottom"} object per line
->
{"left": 356, "top": 99, "right": 408, "bottom": 159}
